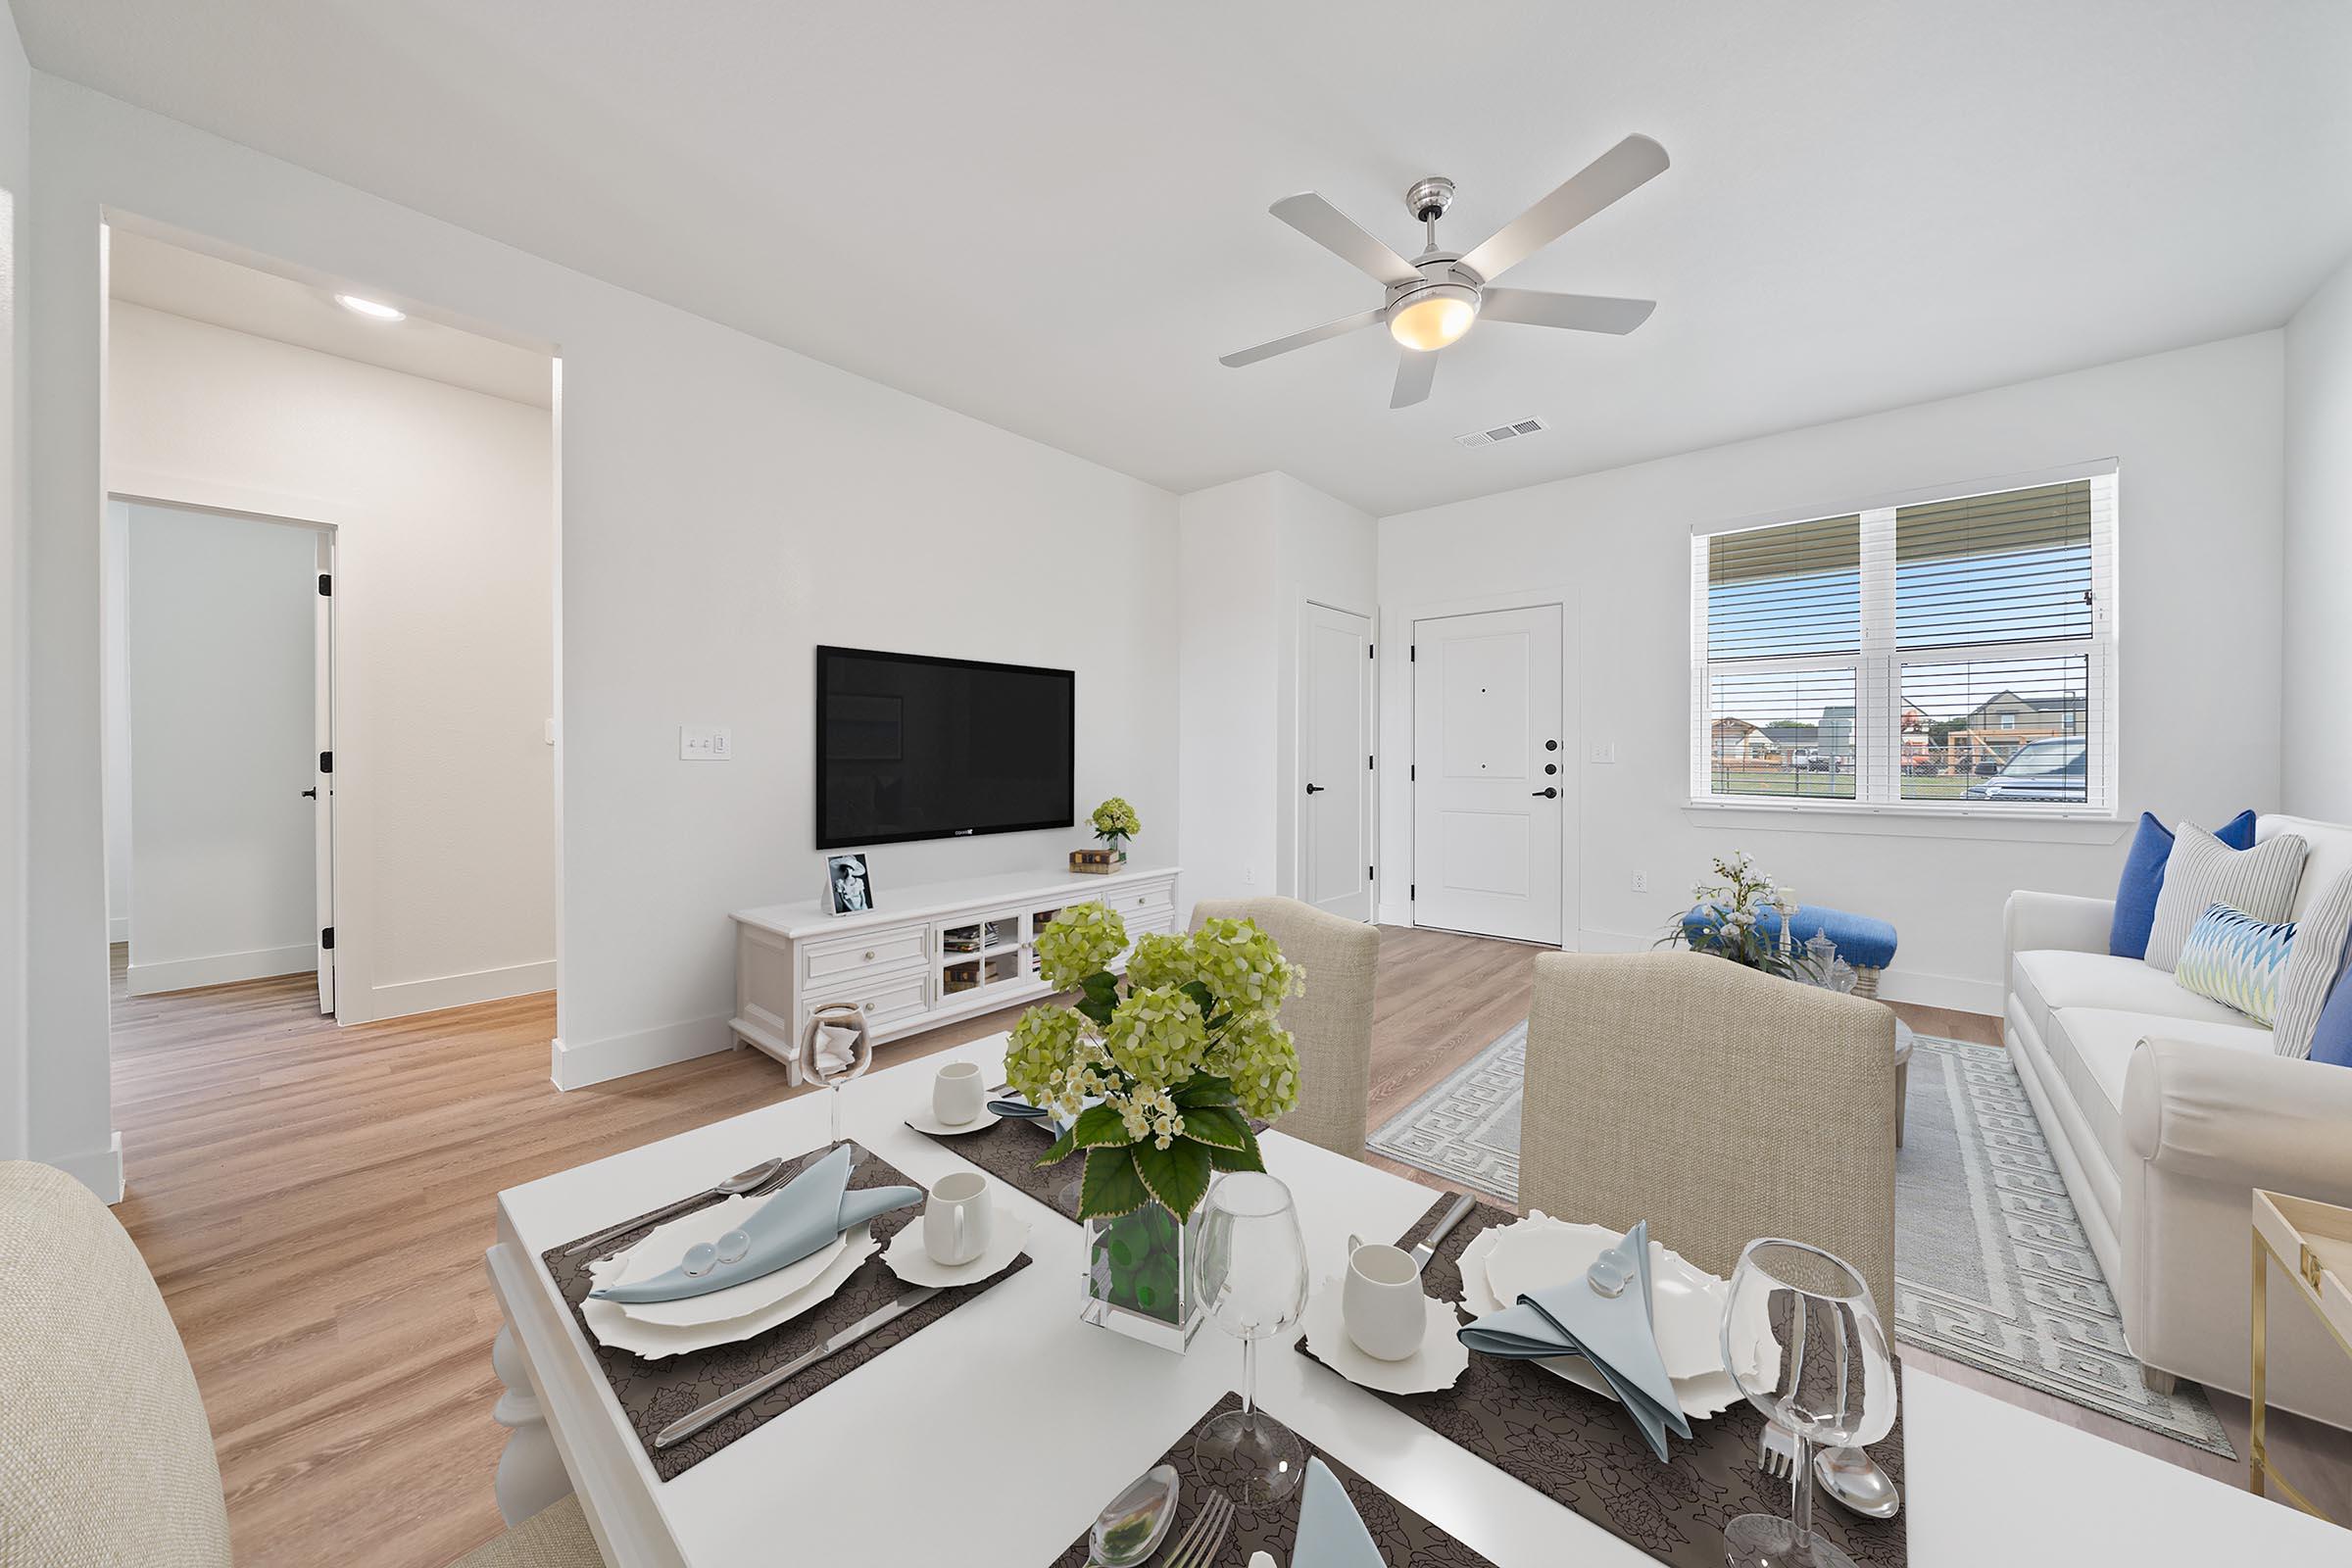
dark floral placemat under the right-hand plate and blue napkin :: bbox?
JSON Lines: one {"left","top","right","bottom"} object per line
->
{"left": 1298, "top": 1195, "right": 1910, "bottom": 1568}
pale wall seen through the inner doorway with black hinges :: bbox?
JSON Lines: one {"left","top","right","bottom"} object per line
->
{"left": 122, "top": 506, "right": 318, "bottom": 995}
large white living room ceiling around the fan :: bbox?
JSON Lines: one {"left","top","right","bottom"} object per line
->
{"left": 14, "top": 0, "right": 2352, "bottom": 513}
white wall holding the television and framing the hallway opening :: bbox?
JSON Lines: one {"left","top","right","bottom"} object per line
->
{"left": 28, "top": 77, "right": 1176, "bottom": 1189}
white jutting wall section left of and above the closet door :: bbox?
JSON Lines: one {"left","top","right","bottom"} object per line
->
{"left": 1176, "top": 472, "right": 1378, "bottom": 926}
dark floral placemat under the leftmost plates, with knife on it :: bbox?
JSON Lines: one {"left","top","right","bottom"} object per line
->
{"left": 539, "top": 1145, "right": 1030, "bottom": 1481}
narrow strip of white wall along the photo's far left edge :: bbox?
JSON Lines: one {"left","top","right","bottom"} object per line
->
{"left": 0, "top": 5, "right": 31, "bottom": 1165}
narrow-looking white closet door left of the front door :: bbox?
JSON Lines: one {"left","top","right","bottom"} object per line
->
{"left": 1298, "top": 604, "right": 1371, "bottom": 919}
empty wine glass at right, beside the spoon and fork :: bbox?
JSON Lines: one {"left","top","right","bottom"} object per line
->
{"left": 1724, "top": 1239, "right": 1895, "bottom": 1568}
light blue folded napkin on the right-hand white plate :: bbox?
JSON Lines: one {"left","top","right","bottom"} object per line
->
{"left": 1460, "top": 1220, "right": 1691, "bottom": 1460}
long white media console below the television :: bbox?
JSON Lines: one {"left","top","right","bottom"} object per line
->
{"left": 729, "top": 865, "right": 1176, "bottom": 1084}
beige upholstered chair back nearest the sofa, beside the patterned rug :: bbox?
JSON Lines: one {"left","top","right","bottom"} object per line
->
{"left": 1519, "top": 953, "right": 1895, "bottom": 1333}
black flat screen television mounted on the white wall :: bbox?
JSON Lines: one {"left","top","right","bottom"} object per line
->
{"left": 816, "top": 647, "right": 1077, "bottom": 849}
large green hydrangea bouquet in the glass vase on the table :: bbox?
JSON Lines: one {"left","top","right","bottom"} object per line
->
{"left": 1004, "top": 903, "right": 1303, "bottom": 1220}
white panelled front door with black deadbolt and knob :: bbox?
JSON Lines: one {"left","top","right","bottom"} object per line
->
{"left": 1413, "top": 604, "right": 1569, "bottom": 948}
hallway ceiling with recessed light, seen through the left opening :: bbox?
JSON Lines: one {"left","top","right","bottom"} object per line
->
{"left": 106, "top": 225, "right": 555, "bottom": 409}
